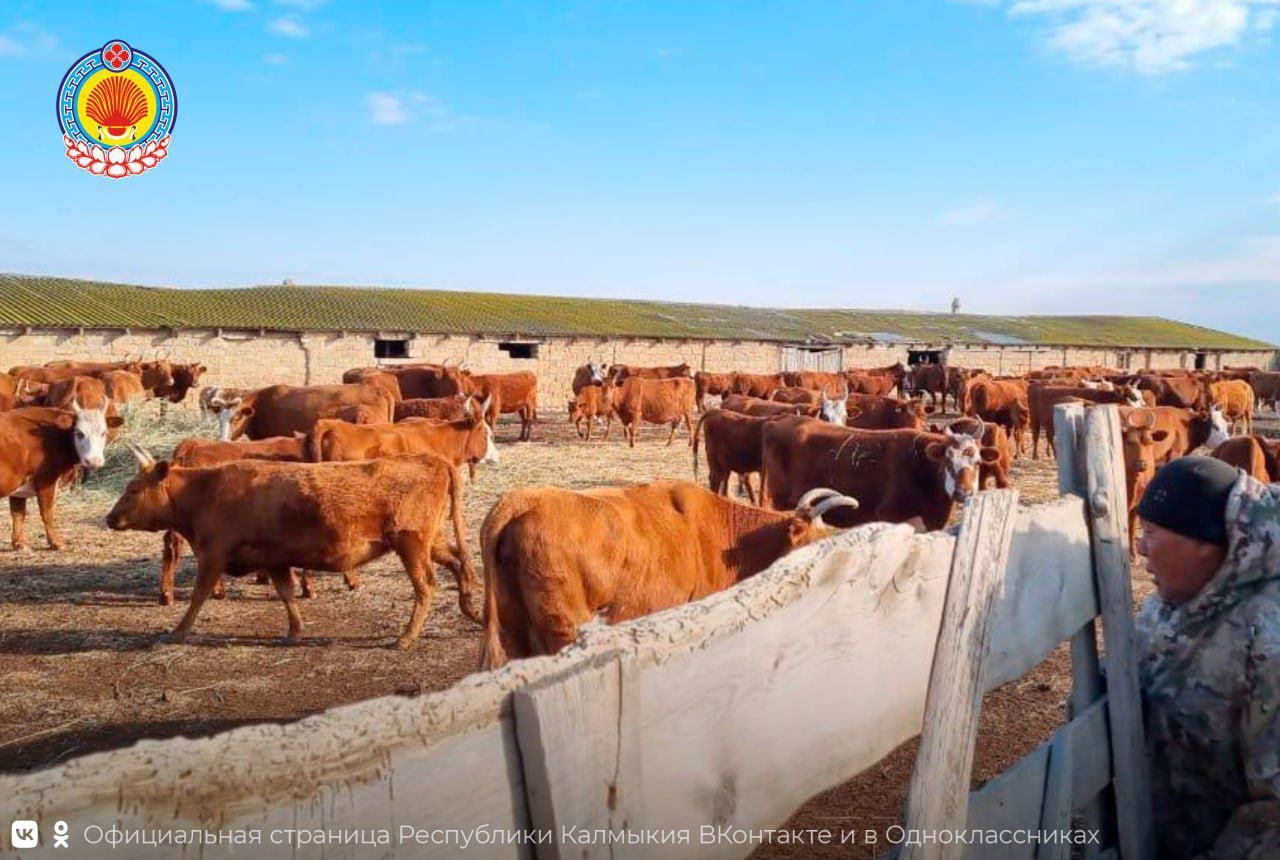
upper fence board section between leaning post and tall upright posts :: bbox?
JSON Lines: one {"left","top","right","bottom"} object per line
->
{"left": 984, "top": 497, "right": 1098, "bottom": 690}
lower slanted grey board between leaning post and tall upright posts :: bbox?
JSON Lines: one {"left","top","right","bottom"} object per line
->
{"left": 969, "top": 700, "right": 1111, "bottom": 860}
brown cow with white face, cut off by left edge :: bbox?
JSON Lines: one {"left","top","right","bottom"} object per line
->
{"left": 0, "top": 399, "right": 123, "bottom": 549}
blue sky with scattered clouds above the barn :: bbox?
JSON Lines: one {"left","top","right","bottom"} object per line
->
{"left": 0, "top": 0, "right": 1280, "bottom": 340}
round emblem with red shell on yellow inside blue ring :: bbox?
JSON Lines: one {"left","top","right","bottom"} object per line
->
{"left": 58, "top": 38, "right": 178, "bottom": 179}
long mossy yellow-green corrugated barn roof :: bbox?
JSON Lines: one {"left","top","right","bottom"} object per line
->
{"left": 0, "top": 274, "right": 1274, "bottom": 349}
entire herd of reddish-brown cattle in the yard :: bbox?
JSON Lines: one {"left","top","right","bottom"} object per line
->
{"left": 0, "top": 360, "right": 1280, "bottom": 668}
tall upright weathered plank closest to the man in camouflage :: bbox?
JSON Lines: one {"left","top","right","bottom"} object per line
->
{"left": 1084, "top": 406, "right": 1156, "bottom": 860}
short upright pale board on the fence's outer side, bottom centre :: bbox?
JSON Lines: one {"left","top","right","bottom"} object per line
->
{"left": 512, "top": 653, "right": 645, "bottom": 860}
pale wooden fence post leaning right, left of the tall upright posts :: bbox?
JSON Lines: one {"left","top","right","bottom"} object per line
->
{"left": 901, "top": 490, "right": 1018, "bottom": 860}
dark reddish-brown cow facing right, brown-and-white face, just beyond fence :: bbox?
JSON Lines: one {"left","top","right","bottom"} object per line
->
{"left": 760, "top": 418, "right": 1000, "bottom": 530}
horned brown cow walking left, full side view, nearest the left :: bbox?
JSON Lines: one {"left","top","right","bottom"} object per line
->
{"left": 106, "top": 450, "right": 476, "bottom": 648}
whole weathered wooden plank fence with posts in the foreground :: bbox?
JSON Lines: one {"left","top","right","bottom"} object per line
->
{"left": 0, "top": 406, "right": 1151, "bottom": 857}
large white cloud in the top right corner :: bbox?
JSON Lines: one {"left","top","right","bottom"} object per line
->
{"left": 1009, "top": 0, "right": 1280, "bottom": 74}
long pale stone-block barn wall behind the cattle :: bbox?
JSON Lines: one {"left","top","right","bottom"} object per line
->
{"left": 0, "top": 329, "right": 1275, "bottom": 408}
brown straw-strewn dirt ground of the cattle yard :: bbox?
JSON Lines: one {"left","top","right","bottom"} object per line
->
{"left": 0, "top": 407, "right": 1259, "bottom": 857}
